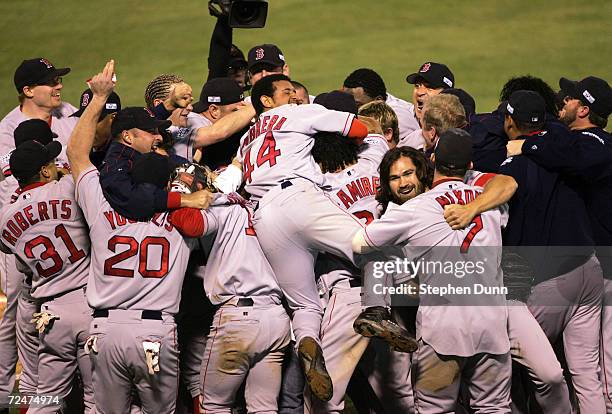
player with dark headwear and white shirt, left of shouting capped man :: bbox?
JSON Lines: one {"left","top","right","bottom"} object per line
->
{"left": 342, "top": 68, "right": 423, "bottom": 148}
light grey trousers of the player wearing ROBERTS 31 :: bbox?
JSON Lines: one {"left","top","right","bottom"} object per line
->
{"left": 29, "top": 290, "right": 93, "bottom": 413}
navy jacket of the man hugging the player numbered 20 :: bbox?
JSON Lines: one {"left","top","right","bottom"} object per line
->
{"left": 99, "top": 142, "right": 180, "bottom": 220}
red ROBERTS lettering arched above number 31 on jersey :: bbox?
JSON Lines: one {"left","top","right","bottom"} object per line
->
{"left": 2, "top": 200, "right": 77, "bottom": 246}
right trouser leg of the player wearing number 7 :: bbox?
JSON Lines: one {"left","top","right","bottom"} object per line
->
{"left": 463, "top": 352, "right": 512, "bottom": 414}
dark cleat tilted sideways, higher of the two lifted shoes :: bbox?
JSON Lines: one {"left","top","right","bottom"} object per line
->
{"left": 353, "top": 306, "right": 419, "bottom": 352}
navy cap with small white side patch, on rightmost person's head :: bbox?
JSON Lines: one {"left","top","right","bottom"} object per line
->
{"left": 559, "top": 76, "right": 612, "bottom": 119}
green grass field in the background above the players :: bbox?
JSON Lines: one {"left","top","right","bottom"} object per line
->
{"left": 0, "top": 0, "right": 612, "bottom": 114}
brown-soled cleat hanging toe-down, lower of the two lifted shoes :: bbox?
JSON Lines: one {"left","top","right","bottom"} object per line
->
{"left": 298, "top": 336, "right": 334, "bottom": 401}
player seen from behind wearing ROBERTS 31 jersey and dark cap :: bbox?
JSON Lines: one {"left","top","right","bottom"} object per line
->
{"left": 0, "top": 140, "right": 94, "bottom": 413}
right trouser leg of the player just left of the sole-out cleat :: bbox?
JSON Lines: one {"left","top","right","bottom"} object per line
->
{"left": 245, "top": 305, "right": 291, "bottom": 413}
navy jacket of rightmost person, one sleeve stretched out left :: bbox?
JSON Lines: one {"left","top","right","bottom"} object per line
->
{"left": 522, "top": 128, "right": 612, "bottom": 279}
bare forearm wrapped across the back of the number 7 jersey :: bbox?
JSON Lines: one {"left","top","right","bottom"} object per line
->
{"left": 444, "top": 174, "right": 518, "bottom": 230}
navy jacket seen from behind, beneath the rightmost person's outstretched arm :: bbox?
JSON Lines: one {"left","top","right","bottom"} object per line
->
{"left": 499, "top": 131, "right": 594, "bottom": 284}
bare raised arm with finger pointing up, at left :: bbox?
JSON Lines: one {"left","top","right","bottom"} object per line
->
{"left": 66, "top": 59, "right": 115, "bottom": 182}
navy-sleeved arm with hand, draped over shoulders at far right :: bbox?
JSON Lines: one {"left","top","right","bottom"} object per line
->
{"left": 506, "top": 133, "right": 612, "bottom": 180}
